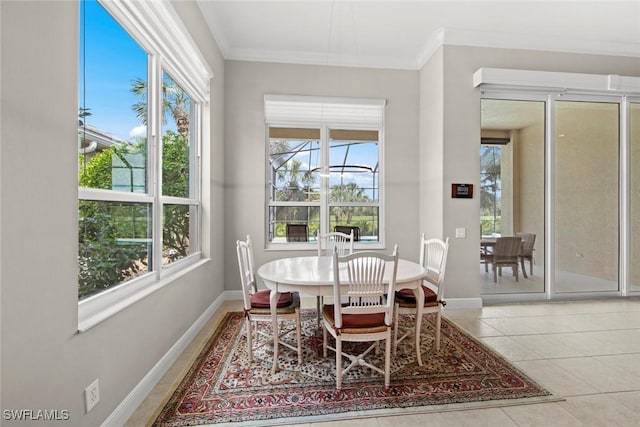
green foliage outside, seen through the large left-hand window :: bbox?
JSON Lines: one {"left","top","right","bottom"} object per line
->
{"left": 78, "top": 131, "right": 190, "bottom": 299}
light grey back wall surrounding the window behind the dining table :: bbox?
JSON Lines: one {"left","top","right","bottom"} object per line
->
{"left": 224, "top": 61, "right": 420, "bottom": 289}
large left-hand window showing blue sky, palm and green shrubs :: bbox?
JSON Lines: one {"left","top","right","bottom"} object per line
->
{"left": 78, "top": 0, "right": 210, "bottom": 326}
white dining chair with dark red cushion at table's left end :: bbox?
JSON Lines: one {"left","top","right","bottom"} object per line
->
{"left": 236, "top": 236, "right": 302, "bottom": 364}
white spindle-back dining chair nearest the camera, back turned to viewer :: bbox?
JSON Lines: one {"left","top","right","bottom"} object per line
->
{"left": 322, "top": 245, "right": 398, "bottom": 390}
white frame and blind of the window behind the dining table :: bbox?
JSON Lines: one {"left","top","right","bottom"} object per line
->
{"left": 264, "top": 95, "right": 386, "bottom": 251}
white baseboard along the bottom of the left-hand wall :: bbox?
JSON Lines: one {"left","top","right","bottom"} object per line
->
{"left": 102, "top": 291, "right": 235, "bottom": 427}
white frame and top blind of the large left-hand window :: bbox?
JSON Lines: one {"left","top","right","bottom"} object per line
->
{"left": 78, "top": 0, "right": 213, "bottom": 332}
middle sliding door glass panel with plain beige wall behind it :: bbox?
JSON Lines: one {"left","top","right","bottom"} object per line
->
{"left": 554, "top": 101, "right": 620, "bottom": 293}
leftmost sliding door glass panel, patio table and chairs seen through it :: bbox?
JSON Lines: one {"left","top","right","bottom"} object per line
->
{"left": 480, "top": 99, "right": 546, "bottom": 295}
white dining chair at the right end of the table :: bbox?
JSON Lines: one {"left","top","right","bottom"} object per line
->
{"left": 393, "top": 233, "right": 449, "bottom": 366}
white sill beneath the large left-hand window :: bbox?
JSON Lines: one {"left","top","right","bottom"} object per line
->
{"left": 78, "top": 258, "right": 210, "bottom": 334}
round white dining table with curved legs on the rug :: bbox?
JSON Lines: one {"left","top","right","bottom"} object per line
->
{"left": 257, "top": 256, "right": 426, "bottom": 372}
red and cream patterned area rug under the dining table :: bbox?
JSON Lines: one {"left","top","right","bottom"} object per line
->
{"left": 153, "top": 310, "right": 555, "bottom": 427}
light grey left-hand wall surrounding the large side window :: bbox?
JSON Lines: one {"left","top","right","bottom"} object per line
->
{"left": 0, "top": 1, "right": 224, "bottom": 426}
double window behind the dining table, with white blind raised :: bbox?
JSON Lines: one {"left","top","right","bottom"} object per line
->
{"left": 265, "top": 97, "right": 384, "bottom": 244}
